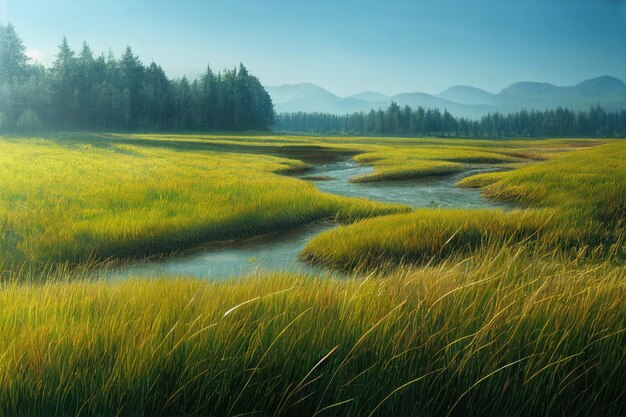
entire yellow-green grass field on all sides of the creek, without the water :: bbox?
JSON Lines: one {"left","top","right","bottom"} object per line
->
{"left": 0, "top": 134, "right": 626, "bottom": 416}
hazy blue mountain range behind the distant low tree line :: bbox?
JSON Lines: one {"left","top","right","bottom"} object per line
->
{"left": 266, "top": 75, "right": 626, "bottom": 118}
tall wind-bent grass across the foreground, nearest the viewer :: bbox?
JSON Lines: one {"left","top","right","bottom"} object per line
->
{"left": 0, "top": 246, "right": 626, "bottom": 417}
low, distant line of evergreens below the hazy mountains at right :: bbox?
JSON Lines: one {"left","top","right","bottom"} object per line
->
{"left": 276, "top": 103, "right": 626, "bottom": 138}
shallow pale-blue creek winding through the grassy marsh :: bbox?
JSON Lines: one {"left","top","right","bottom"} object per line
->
{"left": 109, "top": 159, "right": 504, "bottom": 279}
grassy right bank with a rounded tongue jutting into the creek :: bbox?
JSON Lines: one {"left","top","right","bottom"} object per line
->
{"left": 301, "top": 142, "right": 626, "bottom": 270}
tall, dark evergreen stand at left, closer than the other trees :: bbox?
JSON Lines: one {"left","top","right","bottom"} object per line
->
{"left": 0, "top": 24, "right": 274, "bottom": 131}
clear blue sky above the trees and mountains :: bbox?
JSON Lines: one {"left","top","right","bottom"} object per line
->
{"left": 0, "top": 0, "right": 626, "bottom": 96}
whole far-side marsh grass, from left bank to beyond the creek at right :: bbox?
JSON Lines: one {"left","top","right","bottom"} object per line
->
{"left": 0, "top": 133, "right": 604, "bottom": 279}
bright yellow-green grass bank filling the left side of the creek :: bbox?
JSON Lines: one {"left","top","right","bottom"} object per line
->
{"left": 0, "top": 136, "right": 406, "bottom": 271}
